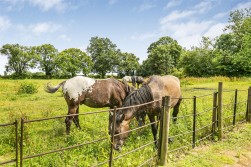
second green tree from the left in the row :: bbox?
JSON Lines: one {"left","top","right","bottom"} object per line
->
{"left": 33, "top": 44, "right": 58, "bottom": 78}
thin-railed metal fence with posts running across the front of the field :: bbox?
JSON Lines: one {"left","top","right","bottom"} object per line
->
{"left": 0, "top": 83, "right": 251, "bottom": 166}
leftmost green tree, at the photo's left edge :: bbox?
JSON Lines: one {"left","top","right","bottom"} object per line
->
{"left": 0, "top": 44, "right": 36, "bottom": 76}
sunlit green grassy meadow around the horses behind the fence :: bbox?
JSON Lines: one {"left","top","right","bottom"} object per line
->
{"left": 0, "top": 77, "right": 251, "bottom": 167}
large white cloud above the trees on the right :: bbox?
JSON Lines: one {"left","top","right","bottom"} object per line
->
{"left": 159, "top": 1, "right": 225, "bottom": 48}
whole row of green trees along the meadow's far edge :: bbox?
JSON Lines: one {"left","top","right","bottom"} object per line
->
{"left": 0, "top": 8, "right": 251, "bottom": 78}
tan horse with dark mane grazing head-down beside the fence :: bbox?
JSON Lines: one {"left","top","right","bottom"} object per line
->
{"left": 113, "top": 75, "right": 181, "bottom": 150}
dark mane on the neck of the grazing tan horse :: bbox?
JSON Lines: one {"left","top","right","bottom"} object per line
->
{"left": 122, "top": 84, "right": 153, "bottom": 107}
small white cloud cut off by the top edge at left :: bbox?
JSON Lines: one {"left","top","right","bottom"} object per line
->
{"left": 29, "top": 0, "right": 68, "bottom": 12}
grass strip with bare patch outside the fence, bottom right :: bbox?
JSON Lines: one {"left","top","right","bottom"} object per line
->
{"left": 169, "top": 124, "right": 251, "bottom": 167}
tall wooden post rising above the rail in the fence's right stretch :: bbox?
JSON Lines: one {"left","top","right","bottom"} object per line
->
{"left": 217, "top": 82, "right": 223, "bottom": 141}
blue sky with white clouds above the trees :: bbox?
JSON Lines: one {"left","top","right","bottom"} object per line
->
{"left": 0, "top": 0, "right": 251, "bottom": 75}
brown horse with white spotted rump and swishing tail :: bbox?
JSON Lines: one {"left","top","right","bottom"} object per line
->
{"left": 45, "top": 76, "right": 134, "bottom": 134}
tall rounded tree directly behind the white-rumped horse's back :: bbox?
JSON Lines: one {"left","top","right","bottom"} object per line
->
{"left": 87, "top": 37, "right": 119, "bottom": 78}
